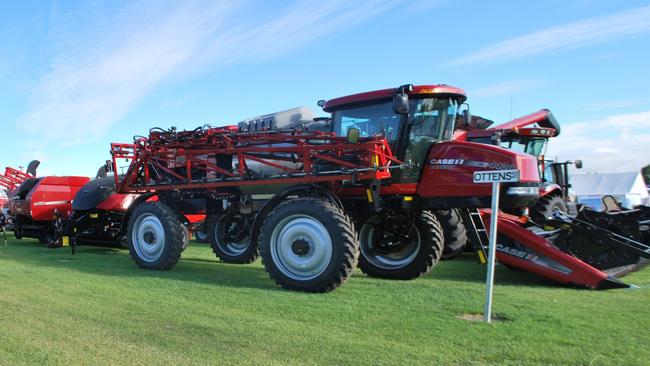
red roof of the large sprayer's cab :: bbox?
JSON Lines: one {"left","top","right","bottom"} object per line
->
{"left": 323, "top": 84, "right": 467, "bottom": 112}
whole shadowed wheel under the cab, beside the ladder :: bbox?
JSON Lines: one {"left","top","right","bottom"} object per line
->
{"left": 359, "top": 211, "right": 444, "bottom": 280}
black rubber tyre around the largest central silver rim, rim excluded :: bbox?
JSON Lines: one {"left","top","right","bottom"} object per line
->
{"left": 259, "top": 197, "right": 359, "bottom": 293}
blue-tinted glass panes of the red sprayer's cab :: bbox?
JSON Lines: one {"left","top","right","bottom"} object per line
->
{"left": 332, "top": 98, "right": 458, "bottom": 149}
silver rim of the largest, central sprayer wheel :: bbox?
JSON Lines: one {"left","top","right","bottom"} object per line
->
{"left": 270, "top": 214, "right": 332, "bottom": 281}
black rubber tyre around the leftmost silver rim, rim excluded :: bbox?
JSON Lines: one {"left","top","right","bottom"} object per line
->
{"left": 127, "top": 202, "right": 183, "bottom": 271}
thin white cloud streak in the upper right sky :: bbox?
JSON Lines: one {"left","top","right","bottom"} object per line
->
{"left": 449, "top": 6, "right": 650, "bottom": 66}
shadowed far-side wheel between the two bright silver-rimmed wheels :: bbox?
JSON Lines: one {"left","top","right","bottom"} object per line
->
{"left": 208, "top": 214, "right": 259, "bottom": 264}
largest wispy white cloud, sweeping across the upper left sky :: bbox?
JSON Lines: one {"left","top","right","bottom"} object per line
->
{"left": 17, "top": 0, "right": 400, "bottom": 144}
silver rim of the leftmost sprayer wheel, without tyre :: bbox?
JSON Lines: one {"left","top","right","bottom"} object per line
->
{"left": 131, "top": 213, "right": 165, "bottom": 262}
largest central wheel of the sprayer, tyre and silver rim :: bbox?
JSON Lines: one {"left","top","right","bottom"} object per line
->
{"left": 260, "top": 198, "right": 359, "bottom": 292}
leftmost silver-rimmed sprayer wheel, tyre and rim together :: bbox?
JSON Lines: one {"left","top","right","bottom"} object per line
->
{"left": 127, "top": 202, "right": 183, "bottom": 270}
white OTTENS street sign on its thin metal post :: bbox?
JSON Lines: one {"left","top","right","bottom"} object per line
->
{"left": 474, "top": 170, "right": 519, "bottom": 323}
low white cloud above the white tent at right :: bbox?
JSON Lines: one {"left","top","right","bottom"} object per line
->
{"left": 546, "top": 111, "right": 650, "bottom": 172}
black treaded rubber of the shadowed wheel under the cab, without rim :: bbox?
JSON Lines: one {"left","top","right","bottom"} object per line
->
{"left": 359, "top": 211, "right": 444, "bottom": 281}
